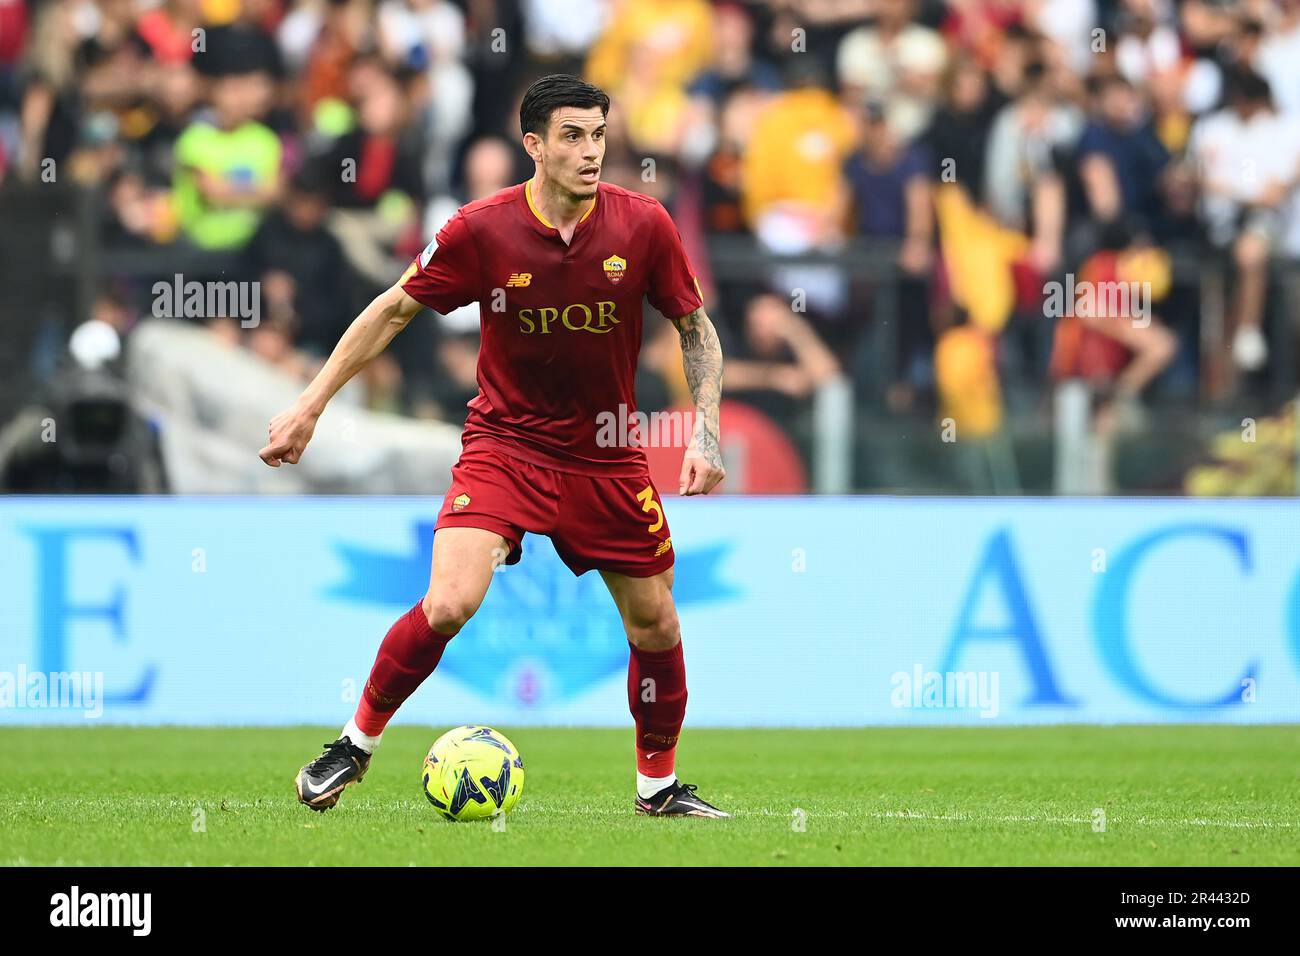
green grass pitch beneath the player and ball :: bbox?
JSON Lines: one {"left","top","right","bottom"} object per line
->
{"left": 0, "top": 726, "right": 1300, "bottom": 866}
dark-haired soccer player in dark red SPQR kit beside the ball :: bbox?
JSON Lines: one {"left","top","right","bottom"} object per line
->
{"left": 260, "top": 74, "right": 729, "bottom": 817}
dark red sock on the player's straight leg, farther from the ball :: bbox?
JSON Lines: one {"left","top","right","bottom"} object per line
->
{"left": 628, "top": 641, "right": 686, "bottom": 777}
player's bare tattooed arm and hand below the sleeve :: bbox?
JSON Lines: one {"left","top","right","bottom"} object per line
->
{"left": 672, "top": 308, "right": 727, "bottom": 494}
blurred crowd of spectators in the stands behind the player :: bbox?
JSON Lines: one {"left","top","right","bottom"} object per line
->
{"left": 0, "top": 0, "right": 1300, "bottom": 476}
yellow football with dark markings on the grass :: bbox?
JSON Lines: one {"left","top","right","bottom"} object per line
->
{"left": 424, "top": 726, "right": 524, "bottom": 821}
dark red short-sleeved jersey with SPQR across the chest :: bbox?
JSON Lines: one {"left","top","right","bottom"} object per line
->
{"left": 402, "top": 183, "right": 702, "bottom": 476}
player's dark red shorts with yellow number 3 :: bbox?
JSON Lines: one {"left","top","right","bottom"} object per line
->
{"left": 437, "top": 445, "right": 673, "bottom": 578}
